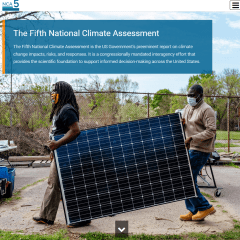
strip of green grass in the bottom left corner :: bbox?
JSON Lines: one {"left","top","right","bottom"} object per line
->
{"left": 0, "top": 229, "right": 69, "bottom": 240}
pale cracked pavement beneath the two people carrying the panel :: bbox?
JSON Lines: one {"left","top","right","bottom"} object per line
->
{"left": 0, "top": 166, "right": 237, "bottom": 234}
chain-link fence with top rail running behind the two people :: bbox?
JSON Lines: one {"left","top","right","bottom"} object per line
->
{"left": 0, "top": 92, "right": 240, "bottom": 155}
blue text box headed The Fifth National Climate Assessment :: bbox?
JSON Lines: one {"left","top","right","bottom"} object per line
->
{"left": 5, "top": 20, "right": 212, "bottom": 74}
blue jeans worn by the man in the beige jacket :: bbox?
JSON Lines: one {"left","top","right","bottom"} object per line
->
{"left": 185, "top": 150, "right": 212, "bottom": 215}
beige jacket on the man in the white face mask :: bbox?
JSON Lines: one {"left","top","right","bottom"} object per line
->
{"left": 183, "top": 100, "right": 216, "bottom": 153}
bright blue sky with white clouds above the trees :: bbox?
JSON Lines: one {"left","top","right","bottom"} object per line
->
{"left": 3, "top": 11, "right": 240, "bottom": 93}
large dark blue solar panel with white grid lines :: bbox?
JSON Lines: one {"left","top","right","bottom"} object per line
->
{"left": 54, "top": 113, "right": 197, "bottom": 224}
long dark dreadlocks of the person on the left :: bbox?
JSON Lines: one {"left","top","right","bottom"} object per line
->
{"left": 49, "top": 81, "right": 79, "bottom": 122}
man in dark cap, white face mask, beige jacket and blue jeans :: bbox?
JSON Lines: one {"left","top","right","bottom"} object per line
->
{"left": 180, "top": 84, "right": 216, "bottom": 221}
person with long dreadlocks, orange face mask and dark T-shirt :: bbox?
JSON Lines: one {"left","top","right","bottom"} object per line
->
{"left": 33, "top": 81, "right": 91, "bottom": 227}
